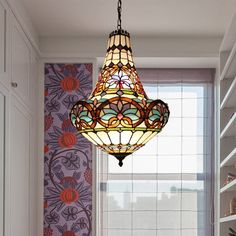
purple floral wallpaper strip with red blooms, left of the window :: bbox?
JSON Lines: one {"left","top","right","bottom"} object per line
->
{"left": 44, "top": 64, "right": 92, "bottom": 236}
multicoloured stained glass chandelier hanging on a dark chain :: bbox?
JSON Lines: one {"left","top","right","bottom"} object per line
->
{"left": 70, "top": 0, "right": 170, "bottom": 166}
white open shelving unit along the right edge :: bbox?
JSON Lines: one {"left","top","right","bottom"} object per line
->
{"left": 218, "top": 11, "right": 236, "bottom": 236}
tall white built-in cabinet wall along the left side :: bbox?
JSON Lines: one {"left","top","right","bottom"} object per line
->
{"left": 0, "top": 0, "right": 42, "bottom": 236}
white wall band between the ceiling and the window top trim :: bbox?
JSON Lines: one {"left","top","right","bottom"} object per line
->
{"left": 40, "top": 32, "right": 222, "bottom": 58}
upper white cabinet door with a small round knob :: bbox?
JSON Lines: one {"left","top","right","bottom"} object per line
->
{"left": 11, "top": 20, "right": 30, "bottom": 105}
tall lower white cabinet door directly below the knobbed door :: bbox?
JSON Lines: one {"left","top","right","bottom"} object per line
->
{"left": 10, "top": 97, "right": 31, "bottom": 236}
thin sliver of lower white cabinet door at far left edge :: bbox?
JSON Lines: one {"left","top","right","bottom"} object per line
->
{"left": 0, "top": 90, "right": 5, "bottom": 236}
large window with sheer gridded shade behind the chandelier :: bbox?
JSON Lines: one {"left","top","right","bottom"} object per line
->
{"left": 97, "top": 69, "right": 214, "bottom": 236}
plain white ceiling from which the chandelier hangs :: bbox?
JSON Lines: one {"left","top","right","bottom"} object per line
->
{"left": 19, "top": 0, "right": 236, "bottom": 37}
